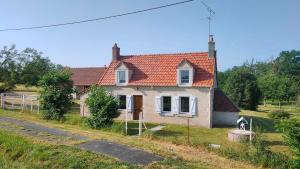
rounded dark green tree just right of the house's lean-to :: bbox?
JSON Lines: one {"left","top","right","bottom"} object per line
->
{"left": 224, "top": 67, "right": 260, "bottom": 110}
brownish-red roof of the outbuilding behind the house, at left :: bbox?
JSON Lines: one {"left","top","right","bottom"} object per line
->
{"left": 70, "top": 67, "right": 105, "bottom": 86}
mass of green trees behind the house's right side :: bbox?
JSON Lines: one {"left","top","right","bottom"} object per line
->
{"left": 218, "top": 50, "right": 300, "bottom": 110}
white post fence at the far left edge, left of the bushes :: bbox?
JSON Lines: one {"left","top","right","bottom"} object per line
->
{"left": 0, "top": 93, "right": 40, "bottom": 112}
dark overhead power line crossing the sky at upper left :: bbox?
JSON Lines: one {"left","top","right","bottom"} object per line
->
{"left": 0, "top": 0, "right": 194, "bottom": 32}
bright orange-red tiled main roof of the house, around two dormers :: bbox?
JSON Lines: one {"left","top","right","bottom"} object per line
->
{"left": 99, "top": 52, "right": 215, "bottom": 87}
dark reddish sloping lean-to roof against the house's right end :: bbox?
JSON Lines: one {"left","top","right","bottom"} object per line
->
{"left": 214, "top": 89, "right": 240, "bottom": 112}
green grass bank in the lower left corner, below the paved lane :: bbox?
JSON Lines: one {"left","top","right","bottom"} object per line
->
{"left": 0, "top": 130, "right": 137, "bottom": 169}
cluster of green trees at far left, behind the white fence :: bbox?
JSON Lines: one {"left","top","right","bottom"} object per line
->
{"left": 0, "top": 45, "right": 63, "bottom": 92}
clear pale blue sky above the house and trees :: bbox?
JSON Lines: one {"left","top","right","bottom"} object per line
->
{"left": 0, "top": 0, "right": 300, "bottom": 71}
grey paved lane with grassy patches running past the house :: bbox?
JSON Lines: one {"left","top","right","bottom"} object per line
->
{"left": 0, "top": 117, "right": 163, "bottom": 165}
